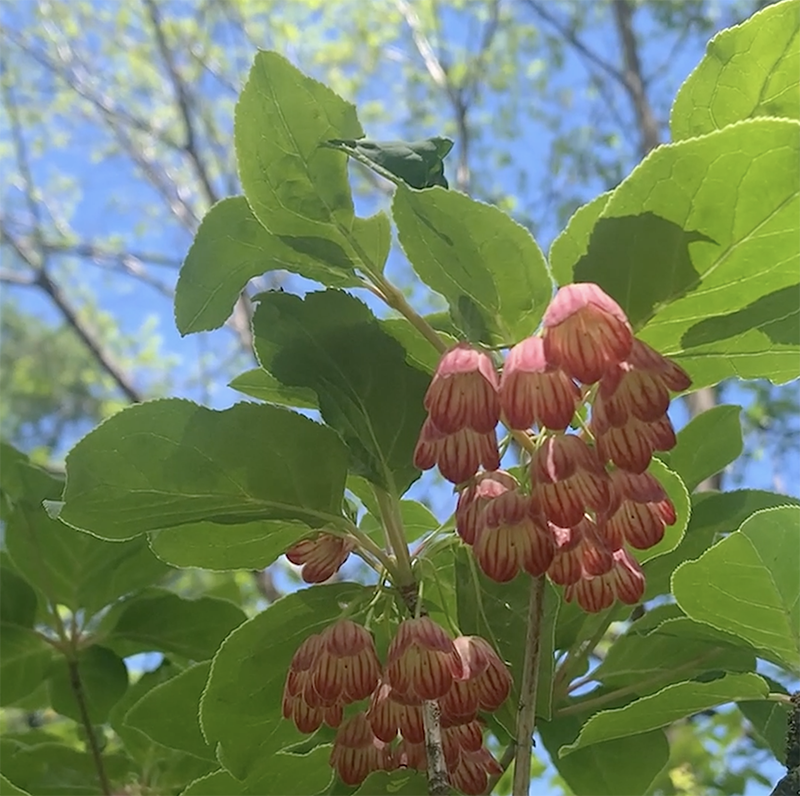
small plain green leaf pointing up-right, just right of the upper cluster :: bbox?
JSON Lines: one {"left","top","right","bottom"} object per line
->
{"left": 667, "top": 406, "right": 743, "bottom": 492}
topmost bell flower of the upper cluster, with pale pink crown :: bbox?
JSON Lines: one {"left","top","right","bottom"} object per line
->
{"left": 543, "top": 282, "right": 633, "bottom": 384}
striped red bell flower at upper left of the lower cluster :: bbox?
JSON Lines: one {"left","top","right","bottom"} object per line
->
{"left": 306, "top": 619, "right": 381, "bottom": 705}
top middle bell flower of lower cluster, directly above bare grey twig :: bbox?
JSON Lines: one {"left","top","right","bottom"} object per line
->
{"left": 385, "top": 616, "right": 463, "bottom": 704}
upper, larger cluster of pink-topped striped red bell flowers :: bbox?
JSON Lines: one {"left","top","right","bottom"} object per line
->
{"left": 414, "top": 283, "right": 691, "bottom": 611}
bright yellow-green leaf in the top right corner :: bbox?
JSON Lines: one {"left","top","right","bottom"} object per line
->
{"left": 670, "top": 2, "right": 800, "bottom": 141}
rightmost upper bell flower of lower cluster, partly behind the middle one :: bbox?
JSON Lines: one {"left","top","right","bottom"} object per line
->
{"left": 439, "top": 636, "right": 512, "bottom": 727}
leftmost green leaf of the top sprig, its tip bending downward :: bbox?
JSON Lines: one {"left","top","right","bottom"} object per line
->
{"left": 175, "top": 201, "right": 361, "bottom": 335}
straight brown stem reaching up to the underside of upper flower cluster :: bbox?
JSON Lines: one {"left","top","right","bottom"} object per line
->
{"left": 513, "top": 576, "right": 545, "bottom": 796}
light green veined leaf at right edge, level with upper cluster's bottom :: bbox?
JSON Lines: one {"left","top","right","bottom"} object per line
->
{"left": 672, "top": 507, "right": 800, "bottom": 669}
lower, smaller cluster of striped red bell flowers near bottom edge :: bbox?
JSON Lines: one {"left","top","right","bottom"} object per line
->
{"left": 283, "top": 617, "right": 511, "bottom": 796}
